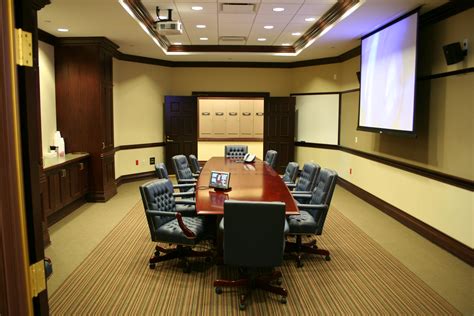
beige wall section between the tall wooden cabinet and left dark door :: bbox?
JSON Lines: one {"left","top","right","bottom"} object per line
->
{"left": 113, "top": 59, "right": 172, "bottom": 178}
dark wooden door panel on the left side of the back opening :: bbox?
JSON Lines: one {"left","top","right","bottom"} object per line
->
{"left": 165, "top": 96, "right": 197, "bottom": 173}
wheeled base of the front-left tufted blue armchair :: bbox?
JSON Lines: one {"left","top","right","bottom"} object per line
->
{"left": 148, "top": 245, "right": 212, "bottom": 273}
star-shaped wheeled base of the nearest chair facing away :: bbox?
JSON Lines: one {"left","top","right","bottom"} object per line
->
{"left": 214, "top": 271, "right": 288, "bottom": 310}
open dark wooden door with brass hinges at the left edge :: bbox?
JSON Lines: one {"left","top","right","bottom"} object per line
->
{"left": 0, "top": 0, "right": 49, "bottom": 315}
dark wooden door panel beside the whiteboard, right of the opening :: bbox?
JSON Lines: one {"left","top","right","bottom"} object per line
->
{"left": 263, "top": 97, "right": 296, "bottom": 173}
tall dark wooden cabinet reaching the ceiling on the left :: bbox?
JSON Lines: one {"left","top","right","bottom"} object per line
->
{"left": 55, "top": 37, "right": 117, "bottom": 201}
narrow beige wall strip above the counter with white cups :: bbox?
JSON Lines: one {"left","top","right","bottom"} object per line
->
{"left": 38, "top": 41, "right": 56, "bottom": 157}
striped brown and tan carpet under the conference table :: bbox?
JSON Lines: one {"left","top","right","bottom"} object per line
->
{"left": 49, "top": 202, "right": 459, "bottom": 315}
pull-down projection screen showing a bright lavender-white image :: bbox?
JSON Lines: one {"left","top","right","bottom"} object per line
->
{"left": 358, "top": 12, "right": 418, "bottom": 134}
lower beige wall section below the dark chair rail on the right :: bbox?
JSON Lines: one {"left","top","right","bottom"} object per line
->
{"left": 295, "top": 147, "right": 474, "bottom": 248}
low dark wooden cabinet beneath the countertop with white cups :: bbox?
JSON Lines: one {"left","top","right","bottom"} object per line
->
{"left": 40, "top": 155, "right": 89, "bottom": 225}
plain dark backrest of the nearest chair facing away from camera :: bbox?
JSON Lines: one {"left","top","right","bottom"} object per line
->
{"left": 224, "top": 200, "right": 285, "bottom": 267}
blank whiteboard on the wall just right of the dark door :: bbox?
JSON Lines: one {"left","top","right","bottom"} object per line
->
{"left": 295, "top": 94, "right": 339, "bottom": 145}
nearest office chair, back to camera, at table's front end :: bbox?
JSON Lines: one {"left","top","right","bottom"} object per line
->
{"left": 214, "top": 200, "right": 288, "bottom": 309}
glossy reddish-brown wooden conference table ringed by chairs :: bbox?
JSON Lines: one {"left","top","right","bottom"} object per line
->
{"left": 196, "top": 157, "right": 299, "bottom": 215}
